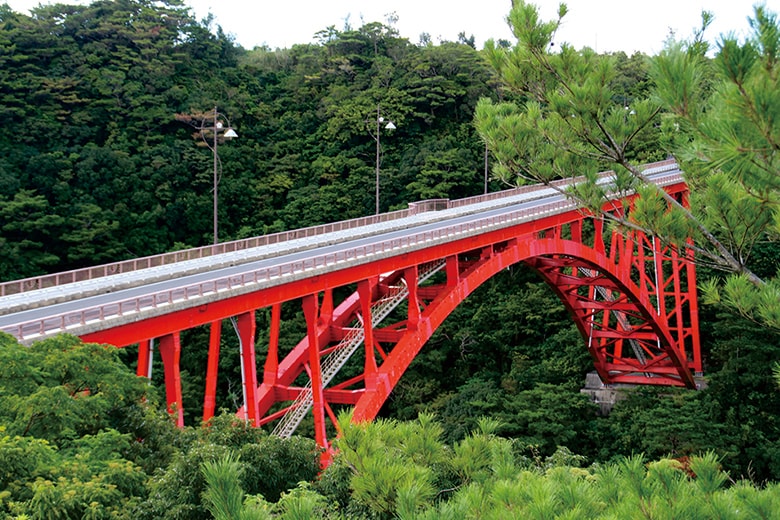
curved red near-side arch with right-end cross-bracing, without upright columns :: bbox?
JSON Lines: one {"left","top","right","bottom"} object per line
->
{"left": 353, "top": 239, "right": 695, "bottom": 421}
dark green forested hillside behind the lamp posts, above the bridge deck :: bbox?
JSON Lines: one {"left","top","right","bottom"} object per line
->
{"left": 0, "top": 0, "right": 496, "bottom": 279}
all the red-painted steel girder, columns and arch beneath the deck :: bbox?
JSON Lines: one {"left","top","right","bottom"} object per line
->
{"left": 61, "top": 172, "right": 702, "bottom": 460}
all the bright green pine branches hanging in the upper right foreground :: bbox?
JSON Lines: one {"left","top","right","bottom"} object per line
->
{"left": 475, "top": 1, "right": 780, "bottom": 328}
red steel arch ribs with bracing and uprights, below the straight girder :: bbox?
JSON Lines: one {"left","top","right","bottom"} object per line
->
{"left": 242, "top": 200, "right": 701, "bottom": 456}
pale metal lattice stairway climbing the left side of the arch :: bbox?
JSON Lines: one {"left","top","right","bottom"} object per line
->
{"left": 272, "top": 260, "right": 445, "bottom": 439}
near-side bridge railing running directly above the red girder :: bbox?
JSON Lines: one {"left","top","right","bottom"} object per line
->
{"left": 2, "top": 173, "right": 682, "bottom": 340}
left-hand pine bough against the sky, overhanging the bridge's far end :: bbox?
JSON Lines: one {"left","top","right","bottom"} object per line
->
{"left": 475, "top": 2, "right": 658, "bottom": 189}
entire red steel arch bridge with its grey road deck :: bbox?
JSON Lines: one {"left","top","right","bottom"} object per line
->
{"left": 0, "top": 161, "right": 702, "bottom": 456}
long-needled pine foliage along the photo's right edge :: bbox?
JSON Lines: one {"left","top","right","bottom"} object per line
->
{"left": 653, "top": 6, "right": 780, "bottom": 312}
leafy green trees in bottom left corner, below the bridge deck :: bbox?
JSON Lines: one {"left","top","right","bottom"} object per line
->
{"left": 0, "top": 335, "right": 151, "bottom": 518}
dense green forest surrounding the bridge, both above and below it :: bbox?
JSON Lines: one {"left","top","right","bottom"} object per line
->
{"left": 0, "top": 0, "right": 780, "bottom": 519}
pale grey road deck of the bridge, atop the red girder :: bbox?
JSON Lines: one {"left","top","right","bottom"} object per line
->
{"left": 0, "top": 161, "right": 682, "bottom": 342}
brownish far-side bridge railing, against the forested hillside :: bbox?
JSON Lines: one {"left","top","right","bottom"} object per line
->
{"left": 0, "top": 159, "right": 677, "bottom": 297}
